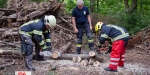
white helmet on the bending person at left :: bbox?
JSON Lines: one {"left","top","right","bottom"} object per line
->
{"left": 44, "top": 15, "right": 56, "bottom": 27}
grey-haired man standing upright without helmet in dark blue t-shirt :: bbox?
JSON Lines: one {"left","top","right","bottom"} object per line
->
{"left": 72, "top": 0, "right": 94, "bottom": 54}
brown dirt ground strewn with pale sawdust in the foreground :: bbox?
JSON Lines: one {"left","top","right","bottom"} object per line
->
{"left": 0, "top": 49, "right": 150, "bottom": 75}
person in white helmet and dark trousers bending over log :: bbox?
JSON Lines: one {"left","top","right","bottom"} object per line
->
{"left": 19, "top": 15, "right": 56, "bottom": 71}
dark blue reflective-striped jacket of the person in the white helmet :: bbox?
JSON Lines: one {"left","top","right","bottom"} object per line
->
{"left": 19, "top": 19, "right": 51, "bottom": 49}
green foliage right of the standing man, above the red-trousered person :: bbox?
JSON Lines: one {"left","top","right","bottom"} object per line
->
{"left": 90, "top": 0, "right": 150, "bottom": 35}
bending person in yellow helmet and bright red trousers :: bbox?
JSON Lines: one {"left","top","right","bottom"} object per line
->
{"left": 95, "top": 22, "right": 130, "bottom": 72}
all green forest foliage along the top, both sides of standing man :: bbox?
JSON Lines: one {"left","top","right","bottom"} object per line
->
{"left": 0, "top": 0, "right": 150, "bottom": 34}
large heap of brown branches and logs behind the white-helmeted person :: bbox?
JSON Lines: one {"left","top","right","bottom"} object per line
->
{"left": 0, "top": 0, "right": 75, "bottom": 49}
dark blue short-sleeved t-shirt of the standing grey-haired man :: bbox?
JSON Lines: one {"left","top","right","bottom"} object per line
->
{"left": 72, "top": 6, "right": 90, "bottom": 25}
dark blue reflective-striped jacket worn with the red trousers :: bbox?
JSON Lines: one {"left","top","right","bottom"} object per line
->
{"left": 99, "top": 25, "right": 129, "bottom": 44}
